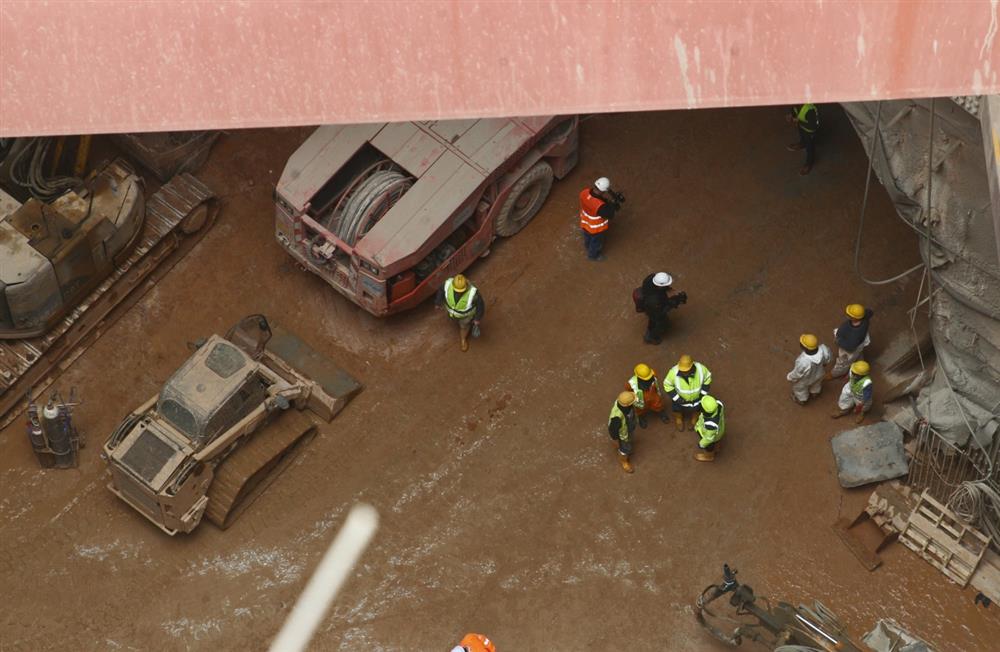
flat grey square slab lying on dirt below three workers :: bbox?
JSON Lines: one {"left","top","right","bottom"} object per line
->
{"left": 830, "top": 421, "right": 909, "bottom": 487}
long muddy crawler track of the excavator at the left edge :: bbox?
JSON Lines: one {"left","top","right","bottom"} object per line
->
{"left": 0, "top": 173, "right": 219, "bottom": 428}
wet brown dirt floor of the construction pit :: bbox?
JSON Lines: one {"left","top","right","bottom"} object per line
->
{"left": 0, "top": 107, "right": 1000, "bottom": 652}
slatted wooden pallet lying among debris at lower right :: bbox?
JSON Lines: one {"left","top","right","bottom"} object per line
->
{"left": 899, "top": 491, "right": 992, "bottom": 587}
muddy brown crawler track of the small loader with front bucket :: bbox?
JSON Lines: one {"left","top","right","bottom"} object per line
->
{"left": 205, "top": 409, "right": 316, "bottom": 530}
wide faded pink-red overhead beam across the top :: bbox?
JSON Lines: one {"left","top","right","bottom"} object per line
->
{"left": 0, "top": 0, "right": 1000, "bottom": 136}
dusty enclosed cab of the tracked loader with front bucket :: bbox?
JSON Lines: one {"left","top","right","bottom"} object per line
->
{"left": 156, "top": 336, "right": 269, "bottom": 450}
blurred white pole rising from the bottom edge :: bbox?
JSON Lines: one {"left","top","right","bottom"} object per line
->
{"left": 270, "top": 503, "right": 378, "bottom": 652}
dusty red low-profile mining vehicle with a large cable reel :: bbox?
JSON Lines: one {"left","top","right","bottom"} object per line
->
{"left": 274, "top": 116, "right": 578, "bottom": 316}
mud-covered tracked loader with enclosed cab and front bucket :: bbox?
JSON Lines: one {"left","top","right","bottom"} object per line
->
{"left": 103, "top": 315, "right": 361, "bottom": 535}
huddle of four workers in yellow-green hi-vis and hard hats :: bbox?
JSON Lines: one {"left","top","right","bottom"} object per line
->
{"left": 608, "top": 354, "right": 726, "bottom": 473}
